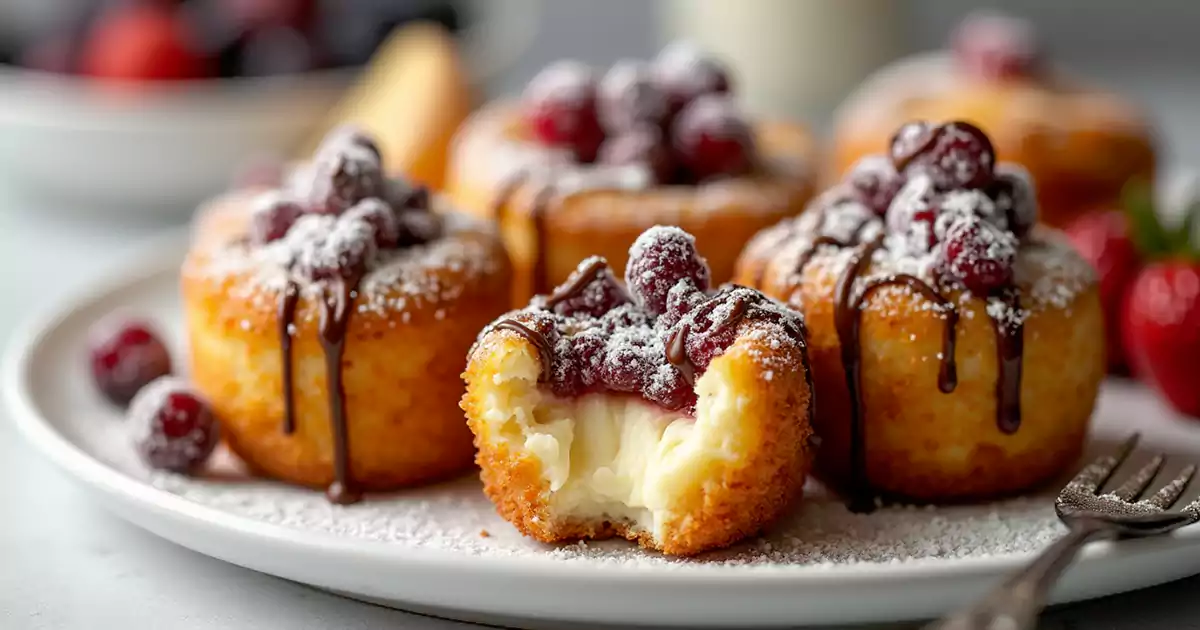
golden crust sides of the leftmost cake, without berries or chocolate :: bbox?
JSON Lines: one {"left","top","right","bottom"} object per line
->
{"left": 182, "top": 204, "right": 511, "bottom": 490}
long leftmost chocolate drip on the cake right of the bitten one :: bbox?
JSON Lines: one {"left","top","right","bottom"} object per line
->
{"left": 834, "top": 236, "right": 883, "bottom": 511}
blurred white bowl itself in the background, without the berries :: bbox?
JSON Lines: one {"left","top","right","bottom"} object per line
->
{"left": 0, "top": 66, "right": 358, "bottom": 217}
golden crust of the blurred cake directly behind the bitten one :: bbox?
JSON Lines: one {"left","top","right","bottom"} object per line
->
{"left": 446, "top": 104, "right": 817, "bottom": 307}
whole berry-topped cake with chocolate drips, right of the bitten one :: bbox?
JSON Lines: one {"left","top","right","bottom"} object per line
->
{"left": 738, "top": 121, "right": 1105, "bottom": 509}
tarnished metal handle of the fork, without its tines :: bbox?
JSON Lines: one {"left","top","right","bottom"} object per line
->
{"left": 924, "top": 521, "right": 1116, "bottom": 630}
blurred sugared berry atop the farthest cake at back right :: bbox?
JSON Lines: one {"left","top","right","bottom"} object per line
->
{"left": 952, "top": 12, "right": 1040, "bottom": 79}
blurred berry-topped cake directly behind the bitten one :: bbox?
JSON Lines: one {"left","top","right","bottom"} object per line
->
{"left": 446, "top": 43, "right": 817, "bottom": 307}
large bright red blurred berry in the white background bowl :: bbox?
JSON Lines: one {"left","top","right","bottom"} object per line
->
{"left": 80, "top": 2, "right": 212, "bottom": 80}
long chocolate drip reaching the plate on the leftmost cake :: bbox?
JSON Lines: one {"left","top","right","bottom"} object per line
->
{"left": 320, "top": 278, "right": 362, "bottom": 505}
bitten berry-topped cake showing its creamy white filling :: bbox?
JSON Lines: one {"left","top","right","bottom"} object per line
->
{"left": 462, "top": 227, "right": 814, "bottom": 556}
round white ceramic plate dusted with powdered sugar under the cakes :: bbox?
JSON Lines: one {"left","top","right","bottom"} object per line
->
{"left": 4, "top": 235, "right": 1200, "bottom": 628}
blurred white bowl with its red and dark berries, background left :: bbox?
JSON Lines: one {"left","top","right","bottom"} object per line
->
{"left": 0, "top": 0, "right": 530, "bottom": 218}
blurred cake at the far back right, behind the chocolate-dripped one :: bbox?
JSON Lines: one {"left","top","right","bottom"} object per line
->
{"left": 829, "top": 12, "right": 1156, "bottom": 228}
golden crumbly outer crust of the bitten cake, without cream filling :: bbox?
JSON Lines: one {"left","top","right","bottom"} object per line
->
{"left": 462, "top": 322, "right": 812, "bottom": 556}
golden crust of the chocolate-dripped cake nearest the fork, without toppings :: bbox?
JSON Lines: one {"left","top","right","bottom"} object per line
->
{"left": 738, "top": 235, "right": 1104, "bottom": 502}
